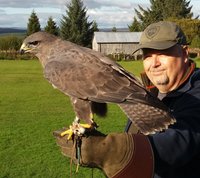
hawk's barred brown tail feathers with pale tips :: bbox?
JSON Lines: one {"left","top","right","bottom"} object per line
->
{"left": 119, "top": 103, "right": 176, "bottom": 135}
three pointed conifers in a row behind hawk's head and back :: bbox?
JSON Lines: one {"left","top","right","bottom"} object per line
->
{"left": 27, "top": 0, "right": 98, "bottom": 47}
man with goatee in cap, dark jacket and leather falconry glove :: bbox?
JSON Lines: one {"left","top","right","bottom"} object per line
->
{"left": 55, "top": 21, "right": 200, "bottom": 178}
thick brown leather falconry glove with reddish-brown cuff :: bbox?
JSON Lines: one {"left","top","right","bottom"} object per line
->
{"left": 54, "top": 131, "right": 153, "bottom": 178}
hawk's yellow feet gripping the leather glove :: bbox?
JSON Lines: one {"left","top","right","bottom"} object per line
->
{"left": 60, "top": 123, "right": 92, "bottom": 140}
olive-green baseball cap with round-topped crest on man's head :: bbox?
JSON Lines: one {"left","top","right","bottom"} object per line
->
{"left": 133, "top": 21, "right": 188, "bottom": 53}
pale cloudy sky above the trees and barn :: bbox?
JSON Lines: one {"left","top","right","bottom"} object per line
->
{"left": 0, "top": 0, "right": 200, "bottom": 28}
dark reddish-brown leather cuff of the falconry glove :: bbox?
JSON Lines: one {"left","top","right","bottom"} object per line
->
{"left": 112, "top": 134, "right": 154, "bottom": 178}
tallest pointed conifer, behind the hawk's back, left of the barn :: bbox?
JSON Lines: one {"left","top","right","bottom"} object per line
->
{"left": 60, "top": 0, "right": 94, "bottom": 47}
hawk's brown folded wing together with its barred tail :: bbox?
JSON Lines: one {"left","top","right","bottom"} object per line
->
{"left": 45, "top": 46, "right": 174, "bottom": 133}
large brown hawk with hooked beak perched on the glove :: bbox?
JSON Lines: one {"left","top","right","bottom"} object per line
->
{"left": 20, "top": 32, "right": 175, "bottom": 135}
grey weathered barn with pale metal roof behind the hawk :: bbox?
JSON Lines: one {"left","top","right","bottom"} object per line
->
{"left": 92, "top": 32, "right": 142, "bottom": 58}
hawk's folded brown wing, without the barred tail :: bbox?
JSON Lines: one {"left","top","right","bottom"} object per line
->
{"left": 44, "top": 45, "right": 146, "bottom": 103}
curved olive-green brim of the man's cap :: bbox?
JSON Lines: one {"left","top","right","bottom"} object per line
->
{"left": 133, "top": 41, "right": 177, "bottom": 53}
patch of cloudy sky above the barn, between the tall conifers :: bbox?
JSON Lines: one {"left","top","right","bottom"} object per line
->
{"left": 84, "top": 0, "right": 149, "bottom": 27}
